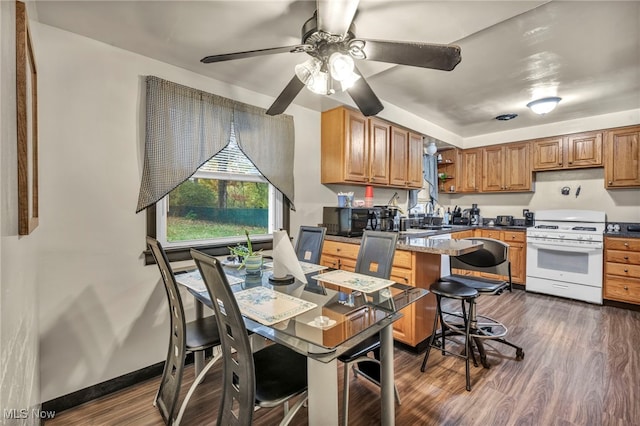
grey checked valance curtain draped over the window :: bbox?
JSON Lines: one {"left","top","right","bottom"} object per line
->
{"left": 136, "top": 76, "right": 295, "bottom": 213}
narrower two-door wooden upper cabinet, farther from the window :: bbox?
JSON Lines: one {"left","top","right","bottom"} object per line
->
{"left": 389, "top": 126, "right": 423, "bottom": 189}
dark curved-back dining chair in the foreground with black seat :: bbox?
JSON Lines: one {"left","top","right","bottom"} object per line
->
{"left": 191, "top": 249, "right": 307, "bottom": 426}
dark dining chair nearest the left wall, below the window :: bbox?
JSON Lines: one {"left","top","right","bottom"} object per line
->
{"left": 147, "top": 237, "right": 221, "bottom": 425}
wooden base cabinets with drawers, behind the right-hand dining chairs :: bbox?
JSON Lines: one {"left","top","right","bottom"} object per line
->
{"left": 320, "top": 240, "right": 440, "bottom": 346}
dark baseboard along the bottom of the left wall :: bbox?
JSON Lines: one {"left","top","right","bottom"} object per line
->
{"left": 42, "top": 353, "right": 193, "bottom": 413}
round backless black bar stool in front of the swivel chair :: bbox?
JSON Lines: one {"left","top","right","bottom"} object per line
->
{"left": 420, "top": 281, "right": 478, "bottom": 391}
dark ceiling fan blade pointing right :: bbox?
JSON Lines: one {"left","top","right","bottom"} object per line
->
{"left": 358, "top": 39, "right": 461, "bottom": 71}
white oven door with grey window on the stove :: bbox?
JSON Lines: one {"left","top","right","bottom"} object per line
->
{"left": 527, "top": 238, "right": 602, "bottom": 287}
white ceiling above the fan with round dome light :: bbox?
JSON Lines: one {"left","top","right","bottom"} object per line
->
{"left": 31, "top": 0, "right": 640, "bottom": 137}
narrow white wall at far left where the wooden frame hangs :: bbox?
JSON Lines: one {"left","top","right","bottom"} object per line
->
{"left": 0, "top": 1, "right": 40, "bottom": 425}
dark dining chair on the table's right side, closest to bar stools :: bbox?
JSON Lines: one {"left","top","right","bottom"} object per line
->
{"left": 338, "top": 231, "right": 401, "bottom": 426}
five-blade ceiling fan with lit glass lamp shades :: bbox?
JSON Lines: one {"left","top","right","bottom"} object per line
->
{"left": 200, "top": 0, "right": 461, "bottom": 116}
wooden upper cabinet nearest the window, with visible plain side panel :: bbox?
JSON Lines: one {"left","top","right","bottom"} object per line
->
{"left": 320, "top": 107, "right": 390, "bottom": 185}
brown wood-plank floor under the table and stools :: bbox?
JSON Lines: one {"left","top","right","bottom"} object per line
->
{"left": 46, "top": 290, "right": 640, "bottom": 426}
